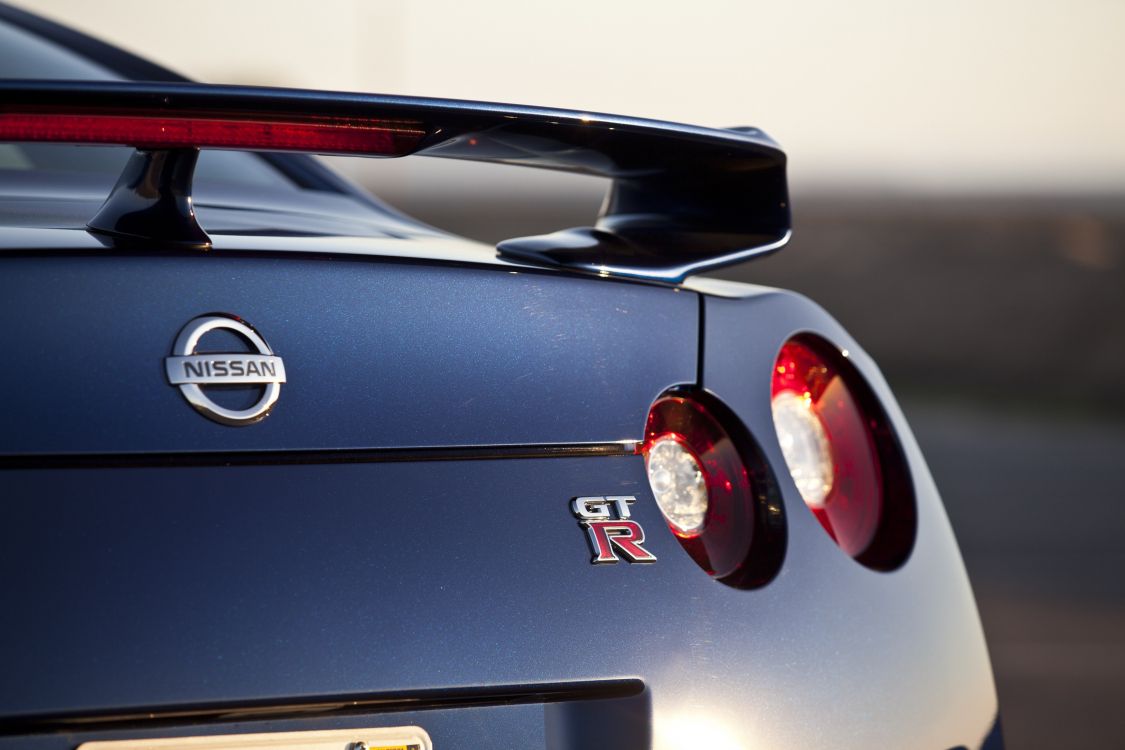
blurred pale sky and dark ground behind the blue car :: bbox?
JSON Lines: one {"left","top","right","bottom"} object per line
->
{"left": 19, "top": 0, "right": 1125, "bottom": 748}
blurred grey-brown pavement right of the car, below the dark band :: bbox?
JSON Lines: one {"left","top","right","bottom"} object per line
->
{"left": 903, "top": 400, "right": 1125, "bottom": 748}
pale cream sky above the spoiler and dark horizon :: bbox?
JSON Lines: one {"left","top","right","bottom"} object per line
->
{"left": 17, "top": 0, "right": 1125, "bottom": 192}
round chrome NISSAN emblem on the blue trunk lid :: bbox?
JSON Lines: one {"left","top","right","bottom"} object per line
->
{"left": 164, "top": 315, "right": 285, "bottom": 427}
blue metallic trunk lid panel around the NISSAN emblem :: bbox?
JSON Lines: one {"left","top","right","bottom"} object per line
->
{"left": 0, "top": 254, "right": 699, "bottom": 454}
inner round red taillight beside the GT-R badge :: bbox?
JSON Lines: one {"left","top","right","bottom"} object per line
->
{"left": 641, "top": 392, "right": 784, "bottom": 588}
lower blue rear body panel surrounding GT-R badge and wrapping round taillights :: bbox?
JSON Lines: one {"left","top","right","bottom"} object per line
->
{"left": 0, "top": 281, "right": 997, "bottom": 748}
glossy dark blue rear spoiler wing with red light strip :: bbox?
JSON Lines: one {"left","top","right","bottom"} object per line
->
{"left": 0, "top": 81, "right": 791, "bottom": 282}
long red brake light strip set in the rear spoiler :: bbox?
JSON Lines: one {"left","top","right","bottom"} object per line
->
{"left": 0, "top": 110, "right": 425, "bottom": 156}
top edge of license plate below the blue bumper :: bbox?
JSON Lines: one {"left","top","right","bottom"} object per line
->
{"left": 78, "top": 726, "right": 433, "bottom": 750}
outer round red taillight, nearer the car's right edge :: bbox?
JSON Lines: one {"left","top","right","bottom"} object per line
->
{"left": 771, "top": 334, "right": 916, "bottom": 570}
